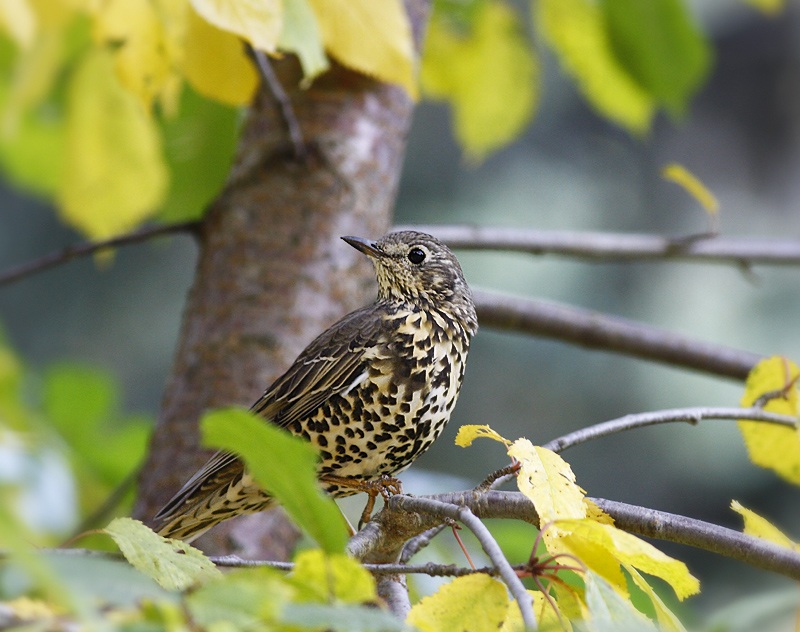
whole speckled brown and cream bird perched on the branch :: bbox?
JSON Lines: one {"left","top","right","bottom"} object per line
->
{"left": 153, "top": 230, "right": 478, "bottom": 542}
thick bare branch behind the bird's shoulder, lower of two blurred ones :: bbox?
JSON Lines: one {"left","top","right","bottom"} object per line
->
{"left": 473, "top": 290, "right": 761, "bottom": 379}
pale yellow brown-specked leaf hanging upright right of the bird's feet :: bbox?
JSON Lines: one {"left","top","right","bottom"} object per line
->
{"left": 508, "top": 439, "right": 587, "bottom": 531}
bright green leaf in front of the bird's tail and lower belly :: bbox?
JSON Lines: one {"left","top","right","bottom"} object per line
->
{"left": 200, "top": 408, "right": 347, "bottom": 553}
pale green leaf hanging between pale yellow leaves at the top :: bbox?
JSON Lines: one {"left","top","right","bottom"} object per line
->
{"left": 278, "top": 0, "right": 330, "bottom": 83}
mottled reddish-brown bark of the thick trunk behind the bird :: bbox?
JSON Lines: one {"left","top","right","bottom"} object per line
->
{"left": 135, "top": 2, "right": 426, "bottom": 559}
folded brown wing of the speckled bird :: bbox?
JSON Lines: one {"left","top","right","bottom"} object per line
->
{"left": 251, "top": 305, "right": 386, "bottom": 427}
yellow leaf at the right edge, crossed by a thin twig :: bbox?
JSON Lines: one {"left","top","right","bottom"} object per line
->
{"left": 739, "top": 356, "right": 800, "bottom": 483}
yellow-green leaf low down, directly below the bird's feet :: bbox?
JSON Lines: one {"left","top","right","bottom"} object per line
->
{"left": 291, "top": 549, "right": 378, "bottom": 603}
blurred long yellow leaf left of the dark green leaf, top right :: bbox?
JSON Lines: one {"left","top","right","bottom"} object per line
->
{"left": 536, "top": 0, "right": 655, "bottom": 134}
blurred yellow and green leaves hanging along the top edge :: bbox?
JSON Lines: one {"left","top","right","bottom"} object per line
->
{"left": 0, "top": 0, "right": 781, "bottom": 239}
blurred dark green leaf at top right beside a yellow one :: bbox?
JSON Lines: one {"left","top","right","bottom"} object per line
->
{"left": 601, "top": 0, "right": 711, "bottom": 116}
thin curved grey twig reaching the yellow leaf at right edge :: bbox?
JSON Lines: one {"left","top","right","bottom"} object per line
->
{"left": 543, "top": 407, "right": 798, "bottom": 452}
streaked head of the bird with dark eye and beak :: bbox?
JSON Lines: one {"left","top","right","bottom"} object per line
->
{"left": 342, "top": 230, "right": 477, "bottom": 333}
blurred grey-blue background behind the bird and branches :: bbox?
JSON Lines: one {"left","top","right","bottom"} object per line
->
{"left": 0, "top": 0, "right": 800, "bottom": 624}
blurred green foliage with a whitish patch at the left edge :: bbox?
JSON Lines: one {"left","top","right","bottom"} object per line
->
{"left": 0, "top": 330, "right": 152, "bottom": 546}
